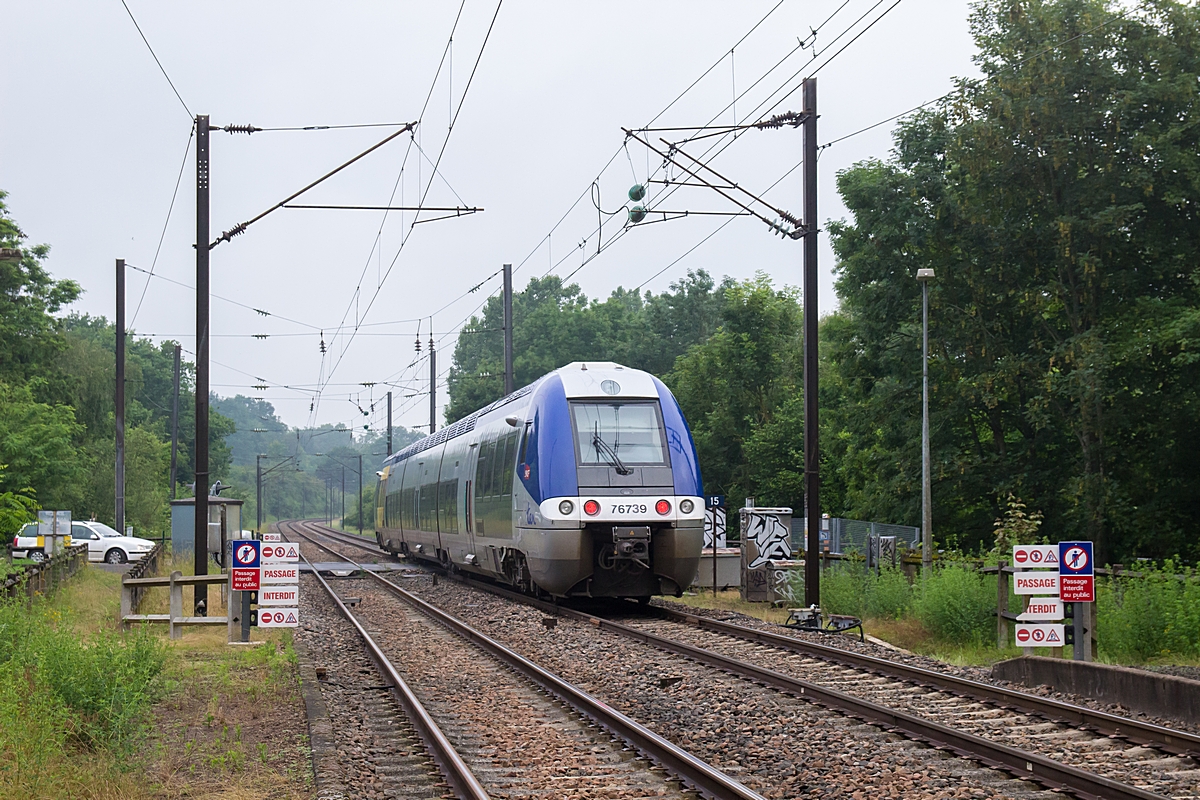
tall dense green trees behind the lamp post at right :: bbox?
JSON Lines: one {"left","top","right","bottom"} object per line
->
{"left": 830, "top": 0, "right": 1200, "bottom": 558}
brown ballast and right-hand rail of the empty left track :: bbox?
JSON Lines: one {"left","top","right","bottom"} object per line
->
{"left": 281, "top": 523, "right": 762, "bottom": 800}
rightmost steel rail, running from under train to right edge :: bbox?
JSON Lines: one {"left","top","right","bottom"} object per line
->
{"left": 652, "top": 607, "right": 1200, "bottom": 759}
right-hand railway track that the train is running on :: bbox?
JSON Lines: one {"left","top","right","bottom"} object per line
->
{"left": 290, "top": 522, "right": 1200, "bottom": 798}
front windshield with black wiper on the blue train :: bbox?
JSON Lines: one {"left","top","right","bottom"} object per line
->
{"left": 571, "top": 403, "right": 667, "bottom": 465}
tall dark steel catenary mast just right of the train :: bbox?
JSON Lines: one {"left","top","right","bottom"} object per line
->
{"left": 803, "top": 78, "right": 821, "bottom": 606}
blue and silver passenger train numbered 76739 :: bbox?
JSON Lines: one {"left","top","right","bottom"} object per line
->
{"left": 376, "top": 362, "right": 704, "bottom": 602}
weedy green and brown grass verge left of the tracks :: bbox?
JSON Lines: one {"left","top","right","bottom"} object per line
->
{"left": 0, "top": 551, "right": 312, "bottom": 800}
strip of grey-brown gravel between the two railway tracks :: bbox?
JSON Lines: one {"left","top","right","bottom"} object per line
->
{"left": 403, "top": 577, "right": 1061, "bottom": 798}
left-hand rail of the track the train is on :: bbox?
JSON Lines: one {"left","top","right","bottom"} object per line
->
{"left": 436, "top": 578, "right": 1165, "bottom": 800}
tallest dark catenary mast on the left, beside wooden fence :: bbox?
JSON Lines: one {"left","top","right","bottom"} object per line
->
{"left": 194, "top": 114, "right": 209, "bottom": 616}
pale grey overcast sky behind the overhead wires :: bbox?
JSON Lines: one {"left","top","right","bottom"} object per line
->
{"left": 0, "top": 0, "right": 977, "bottom": 438}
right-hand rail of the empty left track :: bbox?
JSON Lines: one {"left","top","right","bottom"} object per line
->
{"left": 289, "top": 524, "right": 764, "bottom": 800}
